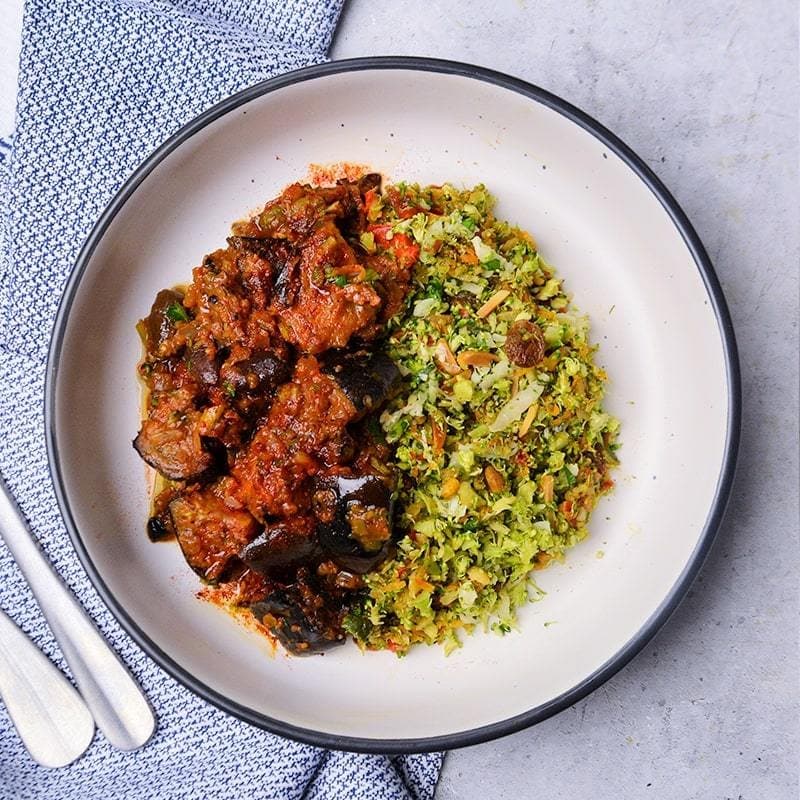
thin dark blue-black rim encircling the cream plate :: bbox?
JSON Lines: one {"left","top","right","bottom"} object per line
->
{"left": 44, "top": 56, "right": 742, "bottom": 754}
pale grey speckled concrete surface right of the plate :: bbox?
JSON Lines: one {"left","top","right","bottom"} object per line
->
{"left": 333, "top": 0, "right": 800, "bottom": 800}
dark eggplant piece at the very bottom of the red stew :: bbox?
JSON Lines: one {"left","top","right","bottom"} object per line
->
{"left": 250, "top": 590, "right": 345, "bottom": 656}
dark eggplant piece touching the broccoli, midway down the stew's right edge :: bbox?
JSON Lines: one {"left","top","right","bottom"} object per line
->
{"left": 319, "top": 350, "right": 400, "bottom": 419}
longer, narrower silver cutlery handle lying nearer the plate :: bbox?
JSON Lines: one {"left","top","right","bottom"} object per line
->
{"left": 0, "top": 479, "right": 155, "bottom": 750}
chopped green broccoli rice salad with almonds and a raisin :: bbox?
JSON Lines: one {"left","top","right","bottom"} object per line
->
{"left": 344, "top": 184, "right": 619, "bottom": 654}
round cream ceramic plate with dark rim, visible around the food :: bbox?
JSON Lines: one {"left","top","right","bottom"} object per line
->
{"left": 47, "top": 58, "right": 740, "bottom": 752}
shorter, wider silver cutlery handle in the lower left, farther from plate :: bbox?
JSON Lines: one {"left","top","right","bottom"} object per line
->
{"left": 0, "top": 610, "right": 94, "bottom": 768}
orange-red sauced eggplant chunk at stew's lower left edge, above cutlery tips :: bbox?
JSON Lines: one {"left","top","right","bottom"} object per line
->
{"left": 169, "top": 488, "right": 260, "bottom": 583}
